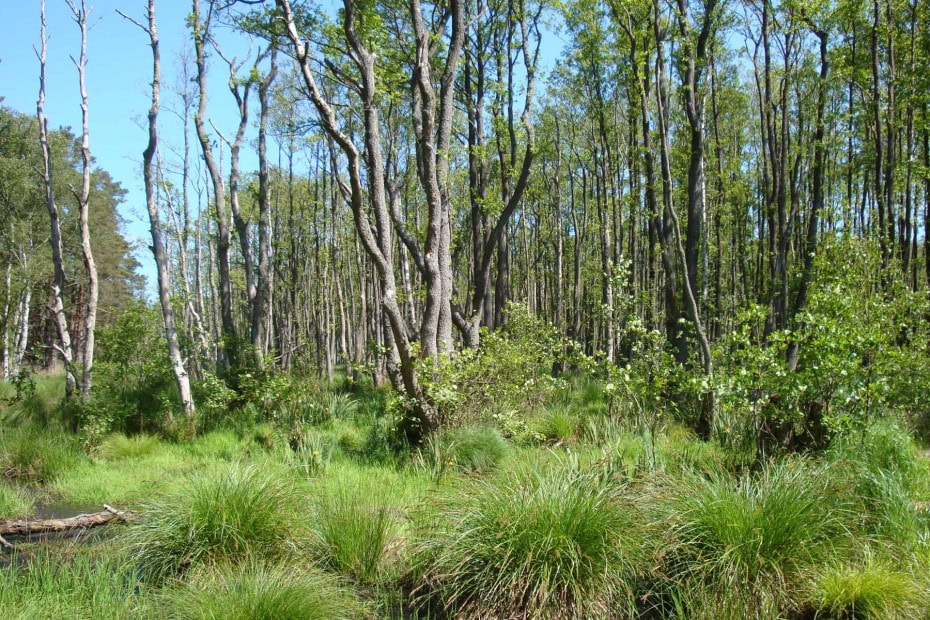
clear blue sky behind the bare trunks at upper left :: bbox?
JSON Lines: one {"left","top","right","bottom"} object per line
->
{"left": 0, "top": 0, "right": 563, "bottom": 294}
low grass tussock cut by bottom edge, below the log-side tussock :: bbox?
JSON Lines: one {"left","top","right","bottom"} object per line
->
{"left": 165, "top": 561, "right": 362, "bottom": 620}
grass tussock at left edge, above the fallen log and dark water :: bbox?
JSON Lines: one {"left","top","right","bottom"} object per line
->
{"left": 0, "top": 426, "right": 81, "bottom": 484}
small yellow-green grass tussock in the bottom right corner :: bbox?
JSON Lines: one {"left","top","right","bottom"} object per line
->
{"left": 808, "top": 556, "right": 930, "bottom": 620}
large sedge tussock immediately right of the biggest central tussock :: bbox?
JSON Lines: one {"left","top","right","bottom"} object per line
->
{"left": 663, "top": 461, "right": 847, "bottom": 617}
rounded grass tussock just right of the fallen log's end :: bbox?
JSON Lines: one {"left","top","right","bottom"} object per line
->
{"left": 128, "top": 464, "right": 298, "bottom": 581}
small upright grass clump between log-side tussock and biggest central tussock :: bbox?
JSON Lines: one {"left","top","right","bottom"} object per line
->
{"left": 313, "top": 487, "right": 394, "bottom": 581}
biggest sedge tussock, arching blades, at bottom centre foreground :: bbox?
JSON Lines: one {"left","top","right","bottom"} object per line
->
{"left": 411, "top": 469, "right": 646, "bottom": 618}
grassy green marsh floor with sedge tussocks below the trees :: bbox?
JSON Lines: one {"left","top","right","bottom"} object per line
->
{"left": 0, "top": 376, "right": 930, "bottom": 619}
